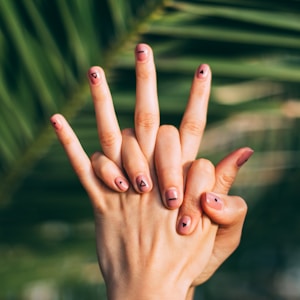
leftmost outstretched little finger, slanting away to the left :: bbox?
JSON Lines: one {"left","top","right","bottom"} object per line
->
{"left": 50, "top": 114, "right": 101, "bottom": 206}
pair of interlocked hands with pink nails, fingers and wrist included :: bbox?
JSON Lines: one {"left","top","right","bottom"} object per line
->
{"left": 51, "top": 44, "right": 253, "bottom": 299}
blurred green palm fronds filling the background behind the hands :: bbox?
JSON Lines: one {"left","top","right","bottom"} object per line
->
{"left": 0, "top": 0, "right": 300, "bottom": 300}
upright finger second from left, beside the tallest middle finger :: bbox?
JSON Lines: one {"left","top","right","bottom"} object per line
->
{"left": 88, "top": 67, "right": 122, "bottom": 166}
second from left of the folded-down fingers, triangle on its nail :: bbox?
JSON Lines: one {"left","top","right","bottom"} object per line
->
{"left": 122, "top": 129, "right": 152, "bottom": 193}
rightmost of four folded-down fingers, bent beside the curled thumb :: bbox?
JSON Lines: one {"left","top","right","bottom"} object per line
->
{"left": 177, "top": 158, "right": 215, "bottom": 235}
